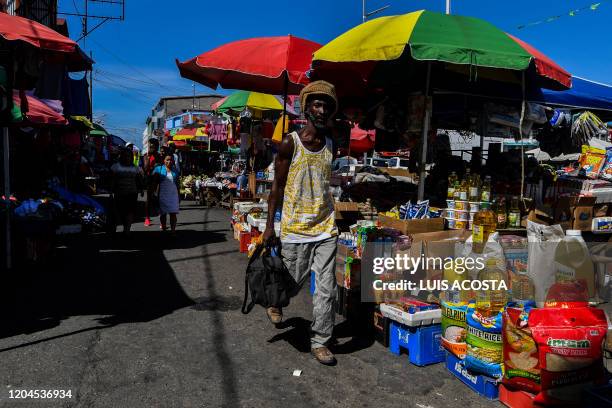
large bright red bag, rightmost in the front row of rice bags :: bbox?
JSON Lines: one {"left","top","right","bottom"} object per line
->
{"left": 529, "top": 307, "right": 608, "bottom": 407}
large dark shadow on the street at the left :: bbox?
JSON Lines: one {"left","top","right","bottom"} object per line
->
{"left": 0, "top": 215, "right": 226, "bottom": 338}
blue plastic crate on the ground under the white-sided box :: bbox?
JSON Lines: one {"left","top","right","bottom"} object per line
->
{"left": 389, "top": 321, "right": 445, "bottom": 366}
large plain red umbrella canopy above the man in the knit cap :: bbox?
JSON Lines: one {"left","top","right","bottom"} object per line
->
{"left": 176, "top": 35, "right": 321, "bottom": 95}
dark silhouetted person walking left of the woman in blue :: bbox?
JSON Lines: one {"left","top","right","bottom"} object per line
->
{"left": 111, "top": 148, "right": 144, "bottom": 237}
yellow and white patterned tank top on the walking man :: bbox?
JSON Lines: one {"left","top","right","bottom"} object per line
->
{"left": 281, "top": 132, "right": 338, "bottom": 243}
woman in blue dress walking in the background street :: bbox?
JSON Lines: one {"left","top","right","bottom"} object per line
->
{"left": 153, "top": 154, "right": 179, "bottom": 235}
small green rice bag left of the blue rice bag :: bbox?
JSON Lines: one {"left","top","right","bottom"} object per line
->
{"left": 440, "top": 301, "right": 467, "bottom": 359}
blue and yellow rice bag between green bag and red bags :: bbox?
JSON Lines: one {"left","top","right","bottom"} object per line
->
{"left": 465, "top": 303, "right": 504, "bottom": 378}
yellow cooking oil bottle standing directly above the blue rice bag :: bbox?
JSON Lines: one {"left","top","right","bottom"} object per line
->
{"left": 476, "top": 258, "right": 508, "bottom": 317}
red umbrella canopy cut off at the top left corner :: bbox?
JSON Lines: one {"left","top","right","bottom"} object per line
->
{"left": 0, "top": 13, "right": 93, "bottom": 71}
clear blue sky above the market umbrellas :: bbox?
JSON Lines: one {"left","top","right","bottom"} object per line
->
{"left": 59, "top": 0, "right": 612, "bottom": 144}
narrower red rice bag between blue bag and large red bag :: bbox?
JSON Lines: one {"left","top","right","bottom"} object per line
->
{"left": 502, "top": 302, "right": 540, "bottom": 394}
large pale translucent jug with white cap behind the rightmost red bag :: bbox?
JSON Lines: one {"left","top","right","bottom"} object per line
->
{"left": 555, "top": 230, "right": 595, "bottom": 298}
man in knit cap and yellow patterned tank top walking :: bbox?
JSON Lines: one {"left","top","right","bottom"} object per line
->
{"left": 263, "top": 81, "right": 338, "bottom": 365}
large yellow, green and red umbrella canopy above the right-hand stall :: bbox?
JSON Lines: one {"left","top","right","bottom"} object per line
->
{"left": 313, "top": 10, "right": 572, "bottom": 88}
